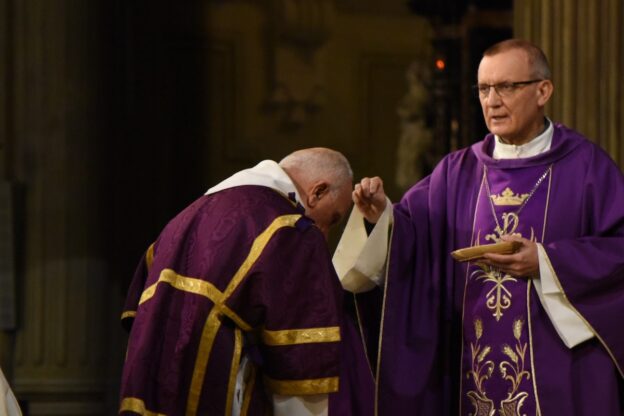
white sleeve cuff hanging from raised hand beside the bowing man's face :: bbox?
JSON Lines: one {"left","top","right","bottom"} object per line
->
{"left": 333, "top": 198, "right": 393, "bottom": 293}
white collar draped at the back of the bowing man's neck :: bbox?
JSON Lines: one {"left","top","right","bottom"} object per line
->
{"left": 206, "top": 160, "right": 301, "bottom": 203}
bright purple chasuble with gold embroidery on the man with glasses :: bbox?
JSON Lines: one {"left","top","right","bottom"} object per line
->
{"left": 377, "top": 125, "right": 624, "bottom": 416}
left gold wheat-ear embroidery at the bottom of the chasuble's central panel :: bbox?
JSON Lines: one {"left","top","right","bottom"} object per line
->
{"left": 466, "top": 318, "right": 495, "bottom": 416}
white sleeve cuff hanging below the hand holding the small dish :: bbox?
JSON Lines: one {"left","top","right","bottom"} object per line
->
{"left": 533, "top": 243, "right": 594, "bottom": 348}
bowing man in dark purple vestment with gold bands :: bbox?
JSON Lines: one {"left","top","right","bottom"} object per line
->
{"left": 119, "top": 148, "right": 372, "bottom": 416}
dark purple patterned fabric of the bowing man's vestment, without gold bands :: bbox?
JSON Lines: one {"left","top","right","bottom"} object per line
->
{"left": 121, "top": 186, "right": 342, "bottom": 415}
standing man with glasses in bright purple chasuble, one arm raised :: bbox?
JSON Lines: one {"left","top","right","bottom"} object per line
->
{"left": 334, "top": 39, "right": 624, "bottom": 416}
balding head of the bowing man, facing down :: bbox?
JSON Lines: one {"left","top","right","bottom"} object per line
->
{"left": 279, "top": 147, "right": 353, "bottom": 238}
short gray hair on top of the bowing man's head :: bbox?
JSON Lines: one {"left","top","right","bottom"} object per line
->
{"left": 279, "top": 147, "right": 353, "bottom": 193}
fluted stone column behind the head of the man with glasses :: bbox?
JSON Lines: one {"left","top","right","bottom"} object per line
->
{"left": 514, "top": 0, "right": 624, "bottom": 166}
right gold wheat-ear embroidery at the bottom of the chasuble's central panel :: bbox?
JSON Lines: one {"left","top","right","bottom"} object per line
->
{"left": 498, "top": 319, "right": 531, "bottom": 416}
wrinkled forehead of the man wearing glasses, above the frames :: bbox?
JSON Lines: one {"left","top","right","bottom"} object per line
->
{"left": 477, "top": 49, "right": 531, "bottom": 84}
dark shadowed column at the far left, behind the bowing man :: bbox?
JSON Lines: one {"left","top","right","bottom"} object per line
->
{"left": 9, "top": 0, "right": 123, "bottom": 416}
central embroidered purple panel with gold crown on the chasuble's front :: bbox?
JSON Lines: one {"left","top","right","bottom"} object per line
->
{"left": 460, "top": 164, "right": 553, "bottom": 415}
